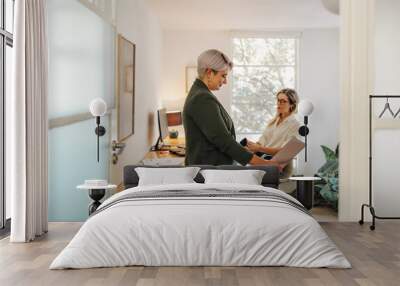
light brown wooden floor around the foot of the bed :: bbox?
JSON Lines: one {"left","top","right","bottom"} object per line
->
{"left": 0, "top": 221, "right": 400, "bottom": 286}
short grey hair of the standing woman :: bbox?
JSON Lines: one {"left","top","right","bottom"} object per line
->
{"left": 197, "top": 49, "right": 233, "bottom": 78}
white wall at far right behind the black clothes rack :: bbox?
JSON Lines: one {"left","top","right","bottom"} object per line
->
{"left": 373, "top": 0, "right": 400, "bottom": 216}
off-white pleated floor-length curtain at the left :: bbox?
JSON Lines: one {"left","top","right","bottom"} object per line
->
{"left": 7, "top": 0, "right": 48, "bottom": 242}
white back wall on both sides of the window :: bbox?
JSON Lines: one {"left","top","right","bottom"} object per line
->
{"left": 161, "top": 28, "right": 339, "bottom": 174}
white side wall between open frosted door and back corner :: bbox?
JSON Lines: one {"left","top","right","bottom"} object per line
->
{"left": 112, "top": 0, "right": 162, "bottom": 182}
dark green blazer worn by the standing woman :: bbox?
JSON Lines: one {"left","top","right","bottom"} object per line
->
{"left": 183, "top": 79, "right": 253, "bottom": 165}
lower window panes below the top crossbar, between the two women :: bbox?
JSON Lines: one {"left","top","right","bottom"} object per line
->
{"left": 232, "top": 67, "right": 295, "bottom": 133}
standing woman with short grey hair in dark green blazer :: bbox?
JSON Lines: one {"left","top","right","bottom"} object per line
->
{"left": 183, "top": 49, "right": 278, "bottom": 165}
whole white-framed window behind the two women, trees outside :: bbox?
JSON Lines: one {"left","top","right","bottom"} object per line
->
{"left": 231, "top": 36, "right": 298, "bottom": 140}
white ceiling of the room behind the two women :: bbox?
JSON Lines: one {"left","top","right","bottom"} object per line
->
{"left": 145, "top": 0, "right": 339, "bottom": 30}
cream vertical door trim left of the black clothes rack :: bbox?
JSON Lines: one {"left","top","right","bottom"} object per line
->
{"left": 339, "top": 0, "right": 375, "bottom": 221}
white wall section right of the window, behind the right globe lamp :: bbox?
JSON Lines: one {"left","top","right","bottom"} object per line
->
{"left": 299, "top": 29, "right": 340, "bottom": 175}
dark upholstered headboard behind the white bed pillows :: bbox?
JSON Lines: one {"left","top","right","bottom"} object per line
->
{"left": 124, "top": 165, "right": 279, "bottom": 189}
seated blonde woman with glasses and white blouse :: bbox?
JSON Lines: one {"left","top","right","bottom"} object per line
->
{"left": 247, "top": 88, "right": 300, "bottom": 175}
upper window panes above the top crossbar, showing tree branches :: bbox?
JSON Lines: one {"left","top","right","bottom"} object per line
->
{"left": 233, "top": 38, "right": 296, "bottom": 65}
